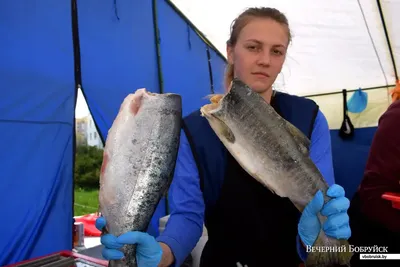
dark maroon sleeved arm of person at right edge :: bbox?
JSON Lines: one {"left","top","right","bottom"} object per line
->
{"left": 359, "top": 100, "right": 400, "bottom": 233}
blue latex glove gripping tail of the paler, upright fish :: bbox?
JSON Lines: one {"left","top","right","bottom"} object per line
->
{"left": 96, "top": 217, "right": 162, "bottom": 267}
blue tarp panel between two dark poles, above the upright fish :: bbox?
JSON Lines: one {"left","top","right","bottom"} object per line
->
{"left": 78, "top": 0, "right": 160, "bottom": 140}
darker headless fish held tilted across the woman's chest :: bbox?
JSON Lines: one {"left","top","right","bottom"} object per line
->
{"left": 201, "top": 79, "right": 352, "bottom": 267}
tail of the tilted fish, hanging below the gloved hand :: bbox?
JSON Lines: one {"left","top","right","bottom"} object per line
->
{"left": 305, "top": 231, "right": 353, "bottom": 267}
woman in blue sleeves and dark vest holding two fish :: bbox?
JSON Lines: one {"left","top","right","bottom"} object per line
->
{"left": 97, "top": 8, "right": 350, "bottom": 267}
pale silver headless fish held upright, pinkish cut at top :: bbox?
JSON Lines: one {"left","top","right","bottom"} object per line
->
{"left": 99, "top": 89, "right": 182, "bottom": 267}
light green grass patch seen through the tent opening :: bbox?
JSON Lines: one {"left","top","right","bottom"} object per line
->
{"left": 74, "top": 188, "right": 99, "bottom": 216}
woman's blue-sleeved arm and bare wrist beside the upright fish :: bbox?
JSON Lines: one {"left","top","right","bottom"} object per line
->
{"left": 157, "top": 131, "right": 205, "bottom": 267}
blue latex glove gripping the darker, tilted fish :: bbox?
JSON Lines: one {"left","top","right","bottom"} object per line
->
{"left": 298, "top": 184, "right": 351, "bottom": 246}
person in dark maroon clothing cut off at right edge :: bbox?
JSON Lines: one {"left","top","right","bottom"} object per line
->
{"left": 348, "top": 98, "right": 400, "bottom": 267}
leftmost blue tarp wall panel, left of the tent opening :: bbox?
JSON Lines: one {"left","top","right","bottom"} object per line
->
{"left": 0, "top": 0, "right": 75, "bottom": 266}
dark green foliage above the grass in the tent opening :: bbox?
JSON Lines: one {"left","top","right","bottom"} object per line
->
{"left": 75, "top": 146, "right": 103, "bottom": 189}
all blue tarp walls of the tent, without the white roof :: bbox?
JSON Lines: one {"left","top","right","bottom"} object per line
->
{"left": 0, "top": 0, "right": 374, "bottom": 265}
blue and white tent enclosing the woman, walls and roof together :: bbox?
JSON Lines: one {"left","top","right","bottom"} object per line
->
{"left": 0, "top": 0, "right": 400, "bottom": 266}
